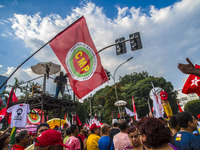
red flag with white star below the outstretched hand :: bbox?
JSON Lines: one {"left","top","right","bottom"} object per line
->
{"left": 182, "top": 65, "right": 200, "bottom": 96}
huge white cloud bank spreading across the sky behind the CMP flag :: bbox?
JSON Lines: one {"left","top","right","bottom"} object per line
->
{"left": 6, "top": 0, "right": 200, "bottom": 91}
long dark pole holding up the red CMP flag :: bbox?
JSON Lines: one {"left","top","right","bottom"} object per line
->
{"left": 0, "top": 16, "right": 83, "bottom": 89}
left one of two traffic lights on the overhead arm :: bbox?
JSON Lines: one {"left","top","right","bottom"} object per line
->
{"left": 115, "top": 37, "right": 126, "bottom": 55}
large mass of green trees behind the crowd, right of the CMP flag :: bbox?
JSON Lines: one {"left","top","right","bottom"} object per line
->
{"left": 77, "top": 72, "right": 178, "bottom": 123}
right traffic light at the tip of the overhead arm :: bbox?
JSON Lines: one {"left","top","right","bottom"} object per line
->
{"left": 129, "top": 32, "right": 142, "bottom": 51}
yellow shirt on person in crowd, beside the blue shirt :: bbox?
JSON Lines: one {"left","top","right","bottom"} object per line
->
{"left": 87, "top": 134, "right": 100, "bottom": 150}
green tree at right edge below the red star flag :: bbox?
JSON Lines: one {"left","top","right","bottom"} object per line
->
{"left": 184, "top": 99, "right": 200, "bottom": 116}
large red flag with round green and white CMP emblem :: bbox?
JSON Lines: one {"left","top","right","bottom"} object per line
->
{"left": 49, "top": 17, "right": 108, "bottom": 99}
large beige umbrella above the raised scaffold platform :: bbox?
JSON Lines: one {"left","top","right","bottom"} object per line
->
{"left": 31, "top": 62, "right": 61, "bottom": 76}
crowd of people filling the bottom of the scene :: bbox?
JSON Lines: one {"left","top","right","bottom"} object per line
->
{"left": 0, "top": 111, "right": 200, "bottom": 150}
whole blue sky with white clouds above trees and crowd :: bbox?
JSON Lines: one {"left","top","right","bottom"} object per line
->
{"left": 0, "top": 0, "right": 200, "bottom": 96}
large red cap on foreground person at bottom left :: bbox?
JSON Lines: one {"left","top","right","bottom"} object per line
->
{"left": 35, "top": 129, "right": 70, "bottom": 148}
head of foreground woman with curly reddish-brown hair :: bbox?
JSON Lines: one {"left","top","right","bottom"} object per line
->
{"left": 136, "top": 117, "right": 177, "bottom": 150}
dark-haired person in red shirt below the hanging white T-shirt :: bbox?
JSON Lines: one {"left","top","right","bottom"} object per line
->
{"left": 12, "top": 130, "right": 29, "bottom": 150}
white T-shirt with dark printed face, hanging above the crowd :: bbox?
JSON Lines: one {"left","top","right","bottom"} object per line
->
{"left": 7, "top": 104, "right": 30, "bottom": 128}
